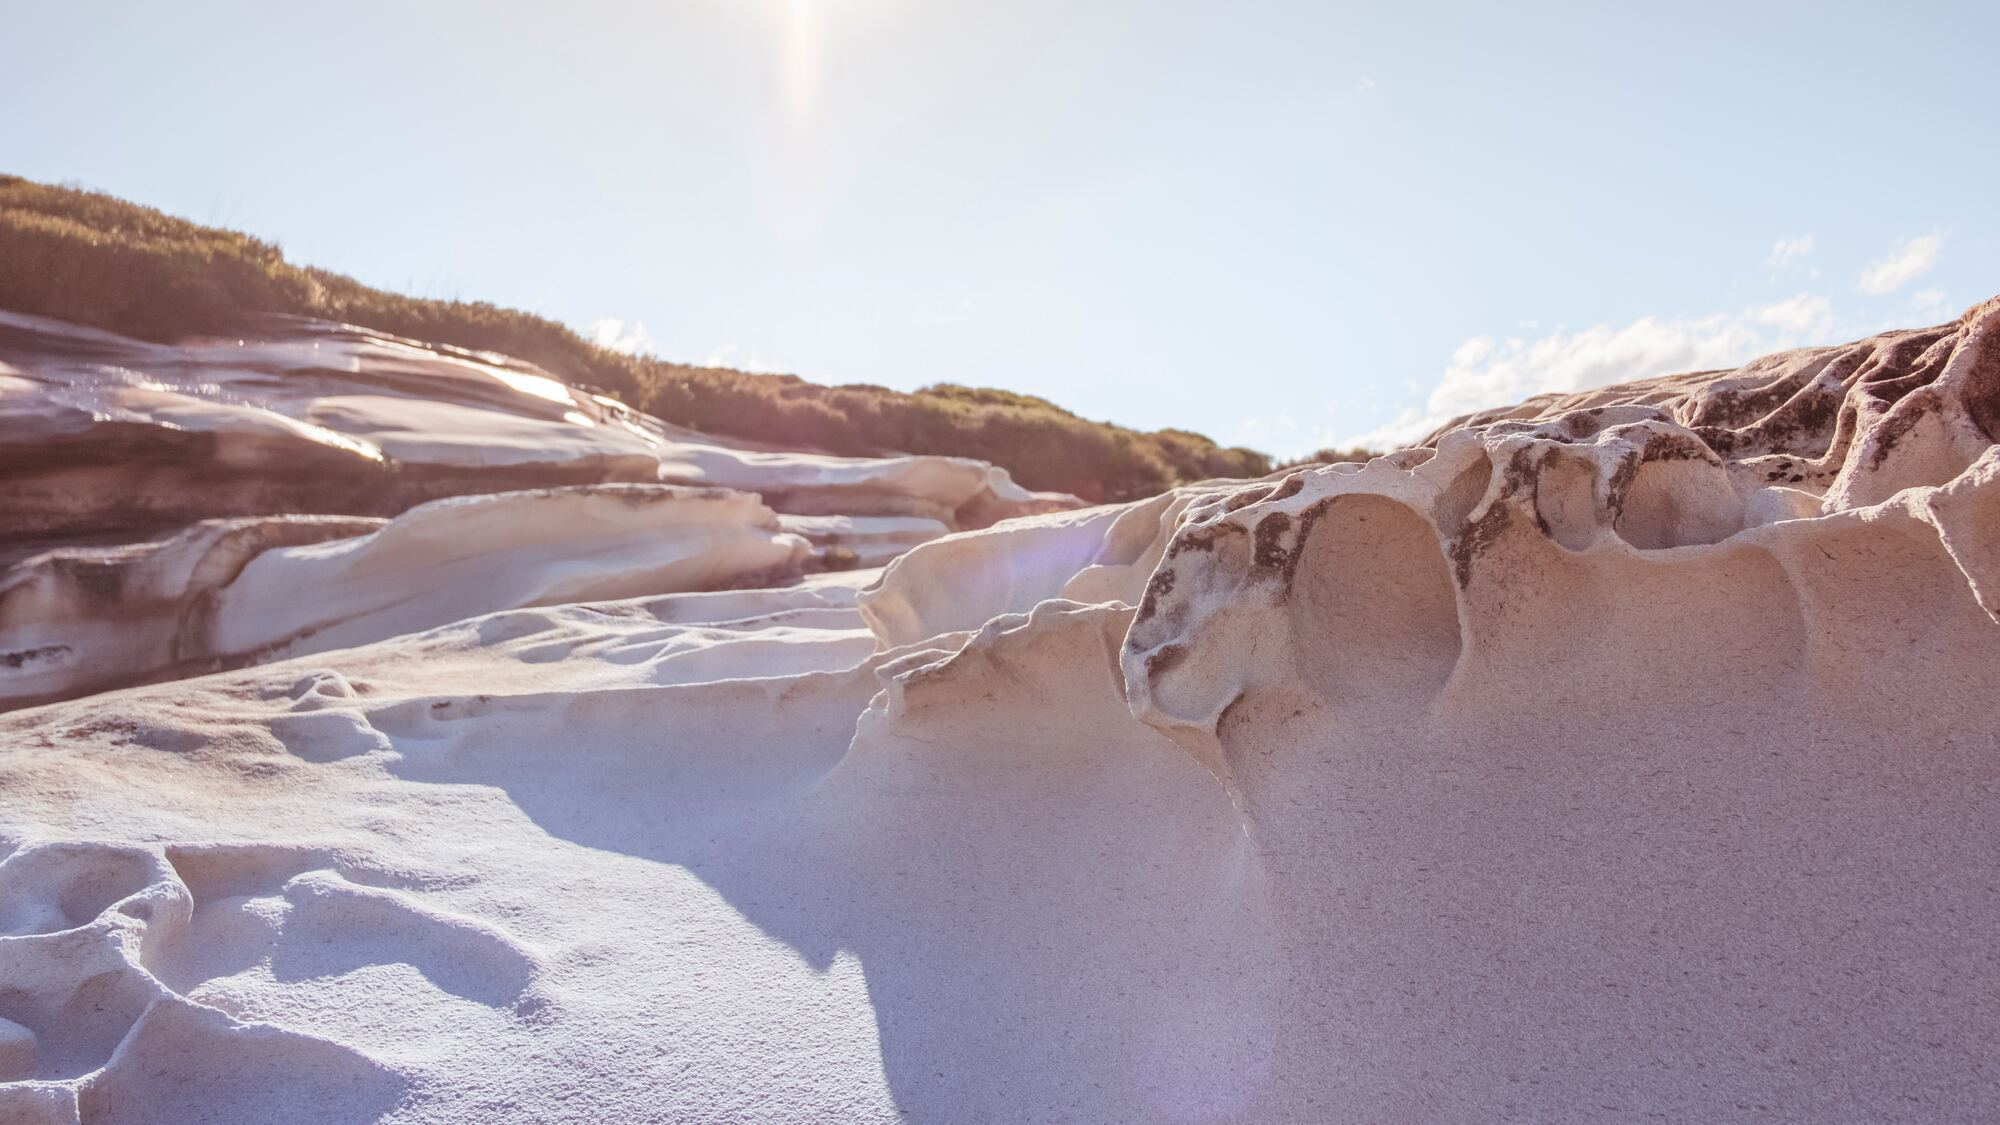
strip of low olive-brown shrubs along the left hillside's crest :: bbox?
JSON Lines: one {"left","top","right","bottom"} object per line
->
{"left": 0, "top": 176, "right": 1270, "bottom": 500}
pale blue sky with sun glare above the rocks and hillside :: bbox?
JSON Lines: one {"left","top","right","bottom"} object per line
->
{"left": 0, "top": 0, "right": 2000, "bottom": 454}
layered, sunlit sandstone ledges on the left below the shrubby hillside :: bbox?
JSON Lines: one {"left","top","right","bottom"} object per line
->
{"left": 0, "top": 312, "right": 1078, "bottom": 709}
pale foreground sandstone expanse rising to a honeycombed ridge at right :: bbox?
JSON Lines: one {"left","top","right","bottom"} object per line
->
{"left": 0, "top": 294, "right": 2000, "bottom": 1121}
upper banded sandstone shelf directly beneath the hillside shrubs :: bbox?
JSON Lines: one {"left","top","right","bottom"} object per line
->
{"left": 0, "top": 312, "right": 1078, "bottom": 546}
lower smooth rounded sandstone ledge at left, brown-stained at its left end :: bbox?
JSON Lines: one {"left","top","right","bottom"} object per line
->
{"left": 0, "top": 484, "right": 810, "bottom": 707}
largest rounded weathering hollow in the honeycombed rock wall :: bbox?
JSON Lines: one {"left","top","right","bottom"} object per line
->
{"left": 1290, "top": 494, "right": 1460, "bottom": 703}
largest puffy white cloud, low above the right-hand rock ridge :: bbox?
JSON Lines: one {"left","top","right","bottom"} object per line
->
{"left": 1320, "top": 292, "right": 1844, "bottom": 448}
